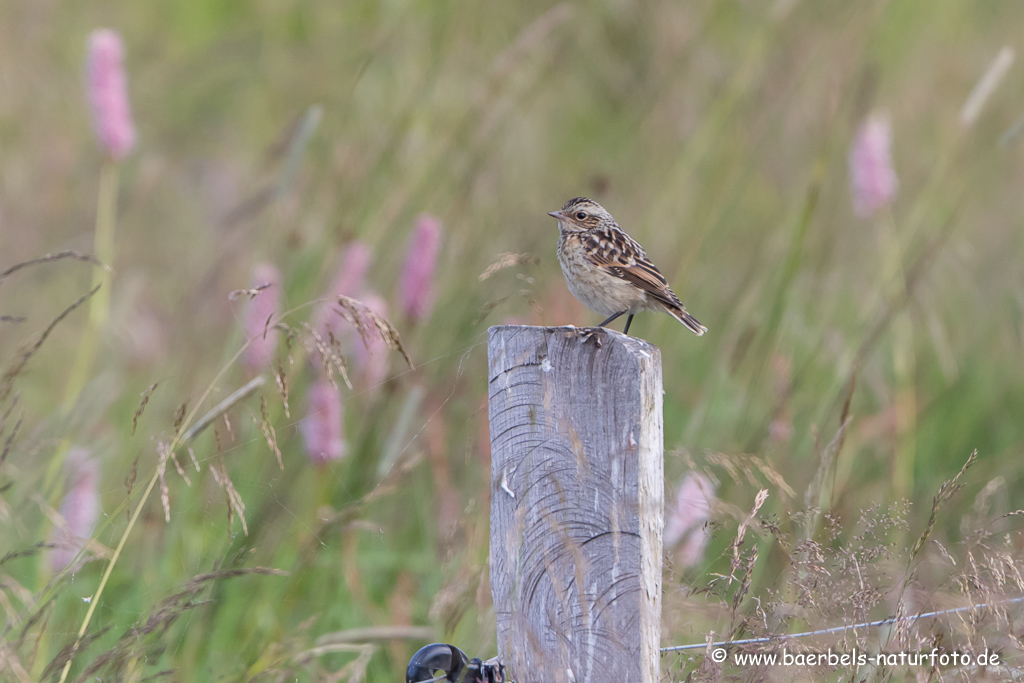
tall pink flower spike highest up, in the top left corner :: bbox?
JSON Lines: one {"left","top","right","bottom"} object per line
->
{"left": 86, "top": 29, "right": 135, "bottom": 161}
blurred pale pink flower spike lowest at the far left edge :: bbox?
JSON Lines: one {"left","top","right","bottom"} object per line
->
{"left": 50, "top": 447, "right": 99, "bottom": 571}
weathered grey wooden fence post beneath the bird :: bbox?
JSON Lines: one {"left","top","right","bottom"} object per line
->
{"left": 487, "top": 326, "right": 665, "bottom": 683}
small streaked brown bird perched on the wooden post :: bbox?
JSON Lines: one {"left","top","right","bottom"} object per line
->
{"left": 548, "top": 197, "right": 708, "bottom": 337}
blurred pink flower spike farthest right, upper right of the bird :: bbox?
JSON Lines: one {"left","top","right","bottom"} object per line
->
{"left": 849, "top": 114, "right": 899, "bottom": 218}
